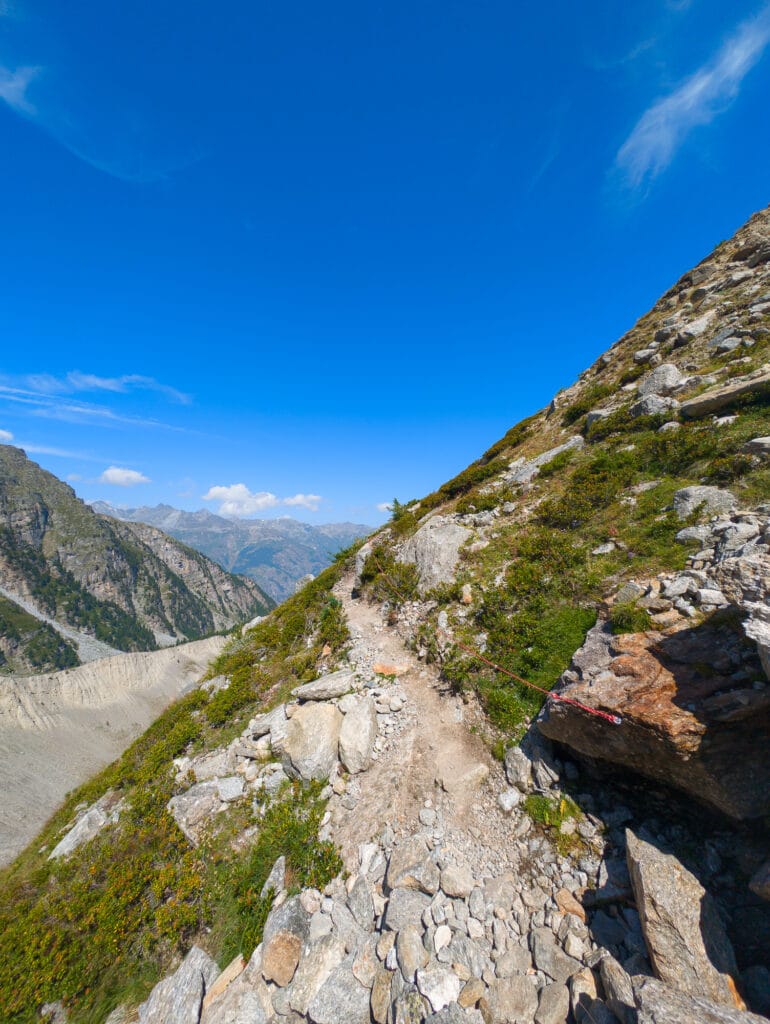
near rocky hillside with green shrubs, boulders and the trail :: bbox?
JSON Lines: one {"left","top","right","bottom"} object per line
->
{"left": 0, "top": 203, "right": 770, "bottom": 1024}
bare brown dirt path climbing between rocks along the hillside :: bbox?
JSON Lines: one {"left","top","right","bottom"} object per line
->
{"left": 332, "top": 575, "right": 510, "bottom": 866}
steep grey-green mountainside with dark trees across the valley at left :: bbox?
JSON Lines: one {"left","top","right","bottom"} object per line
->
{"left": 0, "top": 444, "right": 273, "bottom": 672}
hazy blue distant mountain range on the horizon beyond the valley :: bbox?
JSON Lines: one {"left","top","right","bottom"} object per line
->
{"left": 91, "top": 502, "right": 372, "bottom": 601}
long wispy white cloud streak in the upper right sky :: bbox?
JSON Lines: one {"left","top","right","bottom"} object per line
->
{"left": 615, "top": 4, "right": 770, "bottom": 188}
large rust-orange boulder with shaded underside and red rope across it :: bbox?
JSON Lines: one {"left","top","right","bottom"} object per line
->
{"left": 538, "top": 622, "right": 770, "bottom": 818}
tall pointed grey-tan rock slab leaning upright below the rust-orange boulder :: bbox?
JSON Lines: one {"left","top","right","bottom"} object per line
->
{"left": 626, "top": 828, "right": 737, "bottom": 1007}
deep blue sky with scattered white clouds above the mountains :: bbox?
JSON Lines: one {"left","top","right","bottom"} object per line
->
{"left": 0, "top": 0, "right": 770, "bottom": 523}
